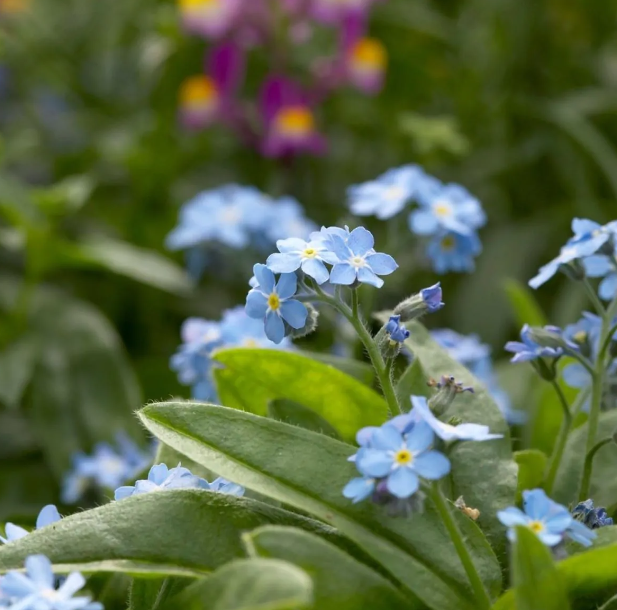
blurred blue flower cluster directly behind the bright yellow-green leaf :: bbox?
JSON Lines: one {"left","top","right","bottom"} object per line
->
{"left": 170, "top": 305, "right": 291, "bottom": 401}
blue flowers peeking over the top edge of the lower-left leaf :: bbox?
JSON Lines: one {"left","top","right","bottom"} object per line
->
{"left": 114, "top": 464, "right": 244, "bottom": 500}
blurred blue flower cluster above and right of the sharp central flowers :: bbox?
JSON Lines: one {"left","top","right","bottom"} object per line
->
{"left": 347, "top": 165, "right": 486, "bottom": 273}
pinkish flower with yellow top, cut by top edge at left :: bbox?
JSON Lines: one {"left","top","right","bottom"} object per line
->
{"left": 178, "top": 0, "right": 245, "bottom": 39}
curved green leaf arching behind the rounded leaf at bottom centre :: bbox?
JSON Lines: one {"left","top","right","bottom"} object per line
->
{"left": 243, "top": 526, "right": 409, "bottom": 610}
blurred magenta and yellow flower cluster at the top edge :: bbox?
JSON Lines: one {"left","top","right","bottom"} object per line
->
{"left": 179, "top": 0, "right": 387, "bottom": 158}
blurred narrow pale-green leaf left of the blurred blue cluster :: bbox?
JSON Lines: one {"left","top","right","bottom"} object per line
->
{"left": 71, "top": 236, "right": 193, "bottom": 294}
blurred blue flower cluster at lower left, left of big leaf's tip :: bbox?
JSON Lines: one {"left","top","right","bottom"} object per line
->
{"left": 61, "top": 433, "right": 153, "bottom": 504}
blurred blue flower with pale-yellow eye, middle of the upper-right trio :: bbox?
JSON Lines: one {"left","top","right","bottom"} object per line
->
{"left": 409, "top": 180, "right": 486, "bottom": 235}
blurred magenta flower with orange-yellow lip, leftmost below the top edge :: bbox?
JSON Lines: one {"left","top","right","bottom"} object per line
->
{"left": 180, "top": 43, "right": 244, "bottom": 129}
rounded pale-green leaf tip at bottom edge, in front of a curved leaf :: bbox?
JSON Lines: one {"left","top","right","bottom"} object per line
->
{"left": 167, "top": 558, "right": 313, "bottom": 610}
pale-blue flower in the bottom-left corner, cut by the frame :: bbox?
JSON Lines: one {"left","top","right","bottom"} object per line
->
{"left": 0, "top": 555, "right": 103, "bottom": 610}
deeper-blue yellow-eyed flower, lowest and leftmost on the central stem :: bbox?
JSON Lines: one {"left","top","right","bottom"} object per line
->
{"left": 246, "top": 264, "right": 308, "bottom": 343}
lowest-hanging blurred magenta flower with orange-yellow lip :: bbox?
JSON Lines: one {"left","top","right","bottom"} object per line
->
{"left": 260, "top": 76, "right": 326, "bottom": 157}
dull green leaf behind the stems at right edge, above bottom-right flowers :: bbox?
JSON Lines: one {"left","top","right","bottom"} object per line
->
{"left": 553, "top": 411, "right": 617, "bottom": 506}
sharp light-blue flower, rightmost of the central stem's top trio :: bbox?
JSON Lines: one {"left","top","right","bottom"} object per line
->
{"left": 330, "top": 227, "right": 398, "bottom": 288}
